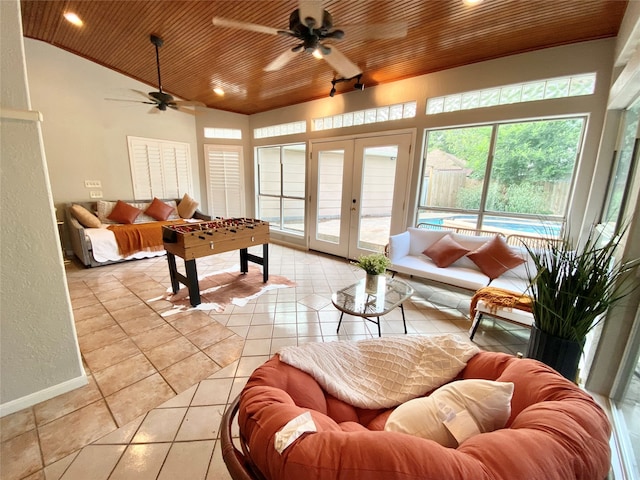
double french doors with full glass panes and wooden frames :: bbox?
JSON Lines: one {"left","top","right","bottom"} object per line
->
{"left": 308, "top": 133, "right": 413, "bottom": 259}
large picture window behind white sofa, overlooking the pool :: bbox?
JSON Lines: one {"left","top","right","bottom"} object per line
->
{"left": 417, "top": 117, "right": 585, "bottom": 236}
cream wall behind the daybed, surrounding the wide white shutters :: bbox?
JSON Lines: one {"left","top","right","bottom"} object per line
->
{"left": 25, "top": 39, "right": 200, "bottom": 210}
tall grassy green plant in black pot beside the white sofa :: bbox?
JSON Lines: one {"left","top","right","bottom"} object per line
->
{"left": 525, "top": 223, "right": 637, "bottom": 381}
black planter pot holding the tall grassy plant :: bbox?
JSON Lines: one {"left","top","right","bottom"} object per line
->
{"left": 527, "top": 325, "right": 584, "bottom": 382}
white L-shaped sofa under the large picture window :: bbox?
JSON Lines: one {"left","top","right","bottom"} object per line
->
{"left": 388, "top": 225, "right": 535, "bottom": 339}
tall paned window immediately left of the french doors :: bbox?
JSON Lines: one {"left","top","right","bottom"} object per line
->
{"left": 256, "top": 144, "right": 306, "bottom": 235}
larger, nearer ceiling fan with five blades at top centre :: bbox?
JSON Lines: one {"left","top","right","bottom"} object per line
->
{"left": 213, "top": 0, "right": 407, "bottom": 79}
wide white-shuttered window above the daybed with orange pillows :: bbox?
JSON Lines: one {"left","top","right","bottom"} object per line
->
{"left": 127, "top": 137, "right": 192, "bottom": 200}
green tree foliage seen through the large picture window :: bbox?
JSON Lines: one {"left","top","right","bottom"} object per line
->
{"left": 428, "top": 118, "right": 584, "bottom": 215}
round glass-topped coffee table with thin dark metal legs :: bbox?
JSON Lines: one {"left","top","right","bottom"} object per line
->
{"left": 331, "top": 275, "right": 413, "bottom": 337}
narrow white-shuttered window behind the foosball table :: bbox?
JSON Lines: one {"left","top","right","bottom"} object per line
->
{"left": 204, "top": 145, "right": 246, "bottom": 218}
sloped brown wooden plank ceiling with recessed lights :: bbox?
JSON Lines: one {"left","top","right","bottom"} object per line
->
{"left": 21, "top": 0, "right": 627, "bottom": 114}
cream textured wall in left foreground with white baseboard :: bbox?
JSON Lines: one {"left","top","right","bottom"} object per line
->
{"left": 0, "top": 0, "right": 87, "bottom": 416}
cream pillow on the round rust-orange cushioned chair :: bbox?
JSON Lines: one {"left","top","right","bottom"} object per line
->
{"left": 384, "top": 380, "right": 513, "bottom": 448}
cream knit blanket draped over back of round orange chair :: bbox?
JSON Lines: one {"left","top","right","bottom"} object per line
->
{"left": 278, "top": 335, "right": 480, "bottom": 409}
